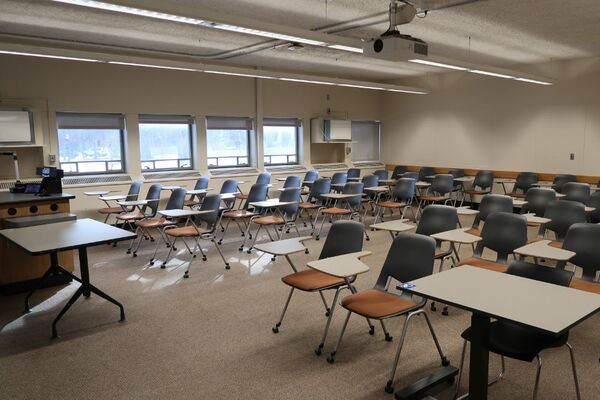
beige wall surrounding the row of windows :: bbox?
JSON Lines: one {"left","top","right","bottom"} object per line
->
{"left": 0, "top": 56, "right": 383, "bottom": 216}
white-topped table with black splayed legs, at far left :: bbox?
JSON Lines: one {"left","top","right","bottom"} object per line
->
{"left": 0, "top": 218, "right": 136, "bottom": 338}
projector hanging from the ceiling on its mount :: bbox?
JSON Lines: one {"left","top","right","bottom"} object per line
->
{"left": 363, "top": 1, "right": 429, "bottom": 61}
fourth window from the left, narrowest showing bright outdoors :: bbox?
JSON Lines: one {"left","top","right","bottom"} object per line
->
{"left": 263, "top": 118, "right": 302, "bottom": 165}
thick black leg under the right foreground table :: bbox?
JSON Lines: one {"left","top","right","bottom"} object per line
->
{"left": 469, "top": 313, "right": 490, "bottom": 400}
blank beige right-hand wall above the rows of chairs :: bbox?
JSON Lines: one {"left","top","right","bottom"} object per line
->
{"left": 382, "top": 59, "right": 600, "bottom": 175}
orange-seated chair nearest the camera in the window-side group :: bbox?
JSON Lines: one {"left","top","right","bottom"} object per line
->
{"left": 161, "top": 194, "right": 230, "bottom": 278}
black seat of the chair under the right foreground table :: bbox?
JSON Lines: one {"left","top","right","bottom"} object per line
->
{"left": 461, "top": 321, "right": 569, "bottom": 362}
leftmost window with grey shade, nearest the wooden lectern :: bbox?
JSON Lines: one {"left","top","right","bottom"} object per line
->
{"left": 56, "top": 113, "right": 125, "bottom": 174}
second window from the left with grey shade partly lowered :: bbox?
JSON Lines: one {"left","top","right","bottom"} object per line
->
{"left": 139, "top": 115, "right": 194, "bottom": 171}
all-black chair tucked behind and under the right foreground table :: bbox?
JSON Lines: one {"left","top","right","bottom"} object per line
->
{"left": 454, "top": 261, "right": 581, "bottom": 400}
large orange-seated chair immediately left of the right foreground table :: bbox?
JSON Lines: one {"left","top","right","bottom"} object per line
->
{"left": 327, "top": 233, "right": 449, "bottom": 393}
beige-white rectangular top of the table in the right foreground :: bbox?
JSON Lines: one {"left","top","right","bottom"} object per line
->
{"left": 403, "top": 265, "right": 600, "bottom": 335}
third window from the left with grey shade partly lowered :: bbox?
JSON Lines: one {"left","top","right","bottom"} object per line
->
{"left": 206, "top": 117, "right": 252, "bottom": 168}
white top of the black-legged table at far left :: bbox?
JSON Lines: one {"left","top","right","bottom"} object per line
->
{"left": 0, "top": 218, "right": 136, "bottom": 255}
